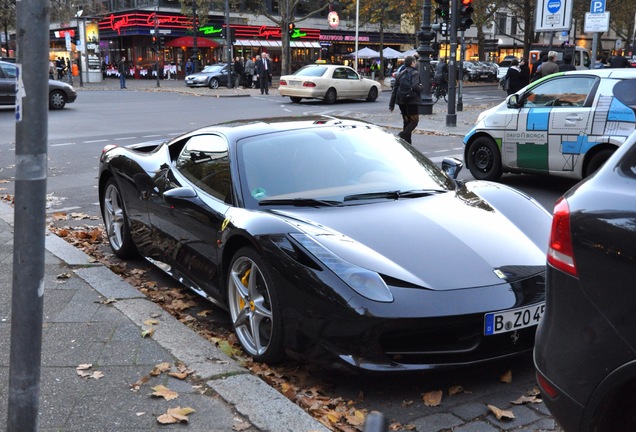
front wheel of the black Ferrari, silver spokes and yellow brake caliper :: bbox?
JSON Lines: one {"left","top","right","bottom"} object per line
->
{"left": 227, "top": 247, "right": 285, "bottom": 364}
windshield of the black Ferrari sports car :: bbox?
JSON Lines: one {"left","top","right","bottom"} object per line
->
{"left": 237, "top": 124, "right": 455, "bottom": 208}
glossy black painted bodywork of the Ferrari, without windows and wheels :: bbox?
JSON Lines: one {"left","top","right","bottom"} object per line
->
{"left": 100, "top": 118, "right": 550, "bottom": 371}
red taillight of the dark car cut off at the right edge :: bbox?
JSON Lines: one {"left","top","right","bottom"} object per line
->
{"left": 548, "top": 197, "right": 578, "bottom": 276}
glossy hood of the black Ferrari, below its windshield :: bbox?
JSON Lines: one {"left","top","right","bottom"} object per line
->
{"left": 273, "top": 192, "right": 546, "bottom": 290}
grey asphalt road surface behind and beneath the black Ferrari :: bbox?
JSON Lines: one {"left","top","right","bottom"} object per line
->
{"left": 0, "top": 87, "right": 574, "bottom": 432}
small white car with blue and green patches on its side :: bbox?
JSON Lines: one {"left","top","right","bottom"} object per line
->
{"left": 464, "top": 68, "right": 636, "bottom": 180}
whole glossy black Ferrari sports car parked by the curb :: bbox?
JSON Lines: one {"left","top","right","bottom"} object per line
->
{"left": 99, "top": 116, "right": 551, "bottom": 371}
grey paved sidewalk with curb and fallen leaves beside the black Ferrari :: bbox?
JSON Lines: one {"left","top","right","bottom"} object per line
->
{"left": 0, "top": 202, "right": 327, "bottom": 432}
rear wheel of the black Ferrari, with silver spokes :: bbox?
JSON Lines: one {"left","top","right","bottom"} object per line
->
{"left": 101, "top": 178, "right": 137, "bottom": 259}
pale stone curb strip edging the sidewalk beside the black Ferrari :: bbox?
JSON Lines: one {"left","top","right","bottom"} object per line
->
{"left": 0, "top": 202, "right": 329, "bottom": 432}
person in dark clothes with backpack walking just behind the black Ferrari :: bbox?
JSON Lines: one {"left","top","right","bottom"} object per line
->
{"left": 389, "top": 56, "right": 423, "bottom": 144}
